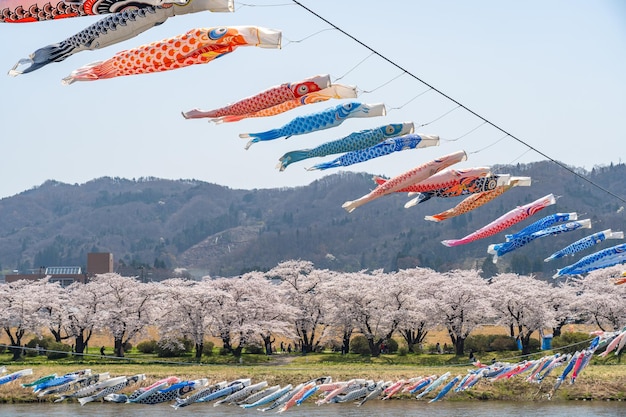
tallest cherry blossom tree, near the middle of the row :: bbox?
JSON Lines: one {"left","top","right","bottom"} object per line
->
{"left": 266, "top": 260, "right": 332, "bottom": 353}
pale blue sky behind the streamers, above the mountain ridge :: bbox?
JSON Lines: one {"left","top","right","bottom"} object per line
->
{"left": 0, "top": 0, "right": 626, "bottom": 197}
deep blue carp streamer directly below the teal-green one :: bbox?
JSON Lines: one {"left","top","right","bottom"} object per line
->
{"left": 307, "top": 133, "right": 439, "bottom": 171}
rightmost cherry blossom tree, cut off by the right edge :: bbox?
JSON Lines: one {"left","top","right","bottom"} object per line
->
{"left": 574, "top": 266, "right": 626, "bottom": 331}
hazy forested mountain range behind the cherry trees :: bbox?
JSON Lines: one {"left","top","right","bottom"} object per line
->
{"left": 0, "top": 162, "right": 626, "bottom": 276}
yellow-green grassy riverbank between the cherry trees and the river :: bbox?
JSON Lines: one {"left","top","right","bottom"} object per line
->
{"left": 0, "top": 352, "right": 626, "bottom": 403}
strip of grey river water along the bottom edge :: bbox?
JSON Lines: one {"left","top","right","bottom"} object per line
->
{"left": 0, "top": 400, "right": 626, "bottom": 417}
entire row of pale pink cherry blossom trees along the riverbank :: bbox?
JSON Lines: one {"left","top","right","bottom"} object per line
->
{"left": 0, "top": 261, "right": 626, "bottom": 358}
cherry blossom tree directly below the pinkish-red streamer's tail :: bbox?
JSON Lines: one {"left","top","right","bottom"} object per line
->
{"left": 424, "top": 270, "right": 494, "bottom": 355}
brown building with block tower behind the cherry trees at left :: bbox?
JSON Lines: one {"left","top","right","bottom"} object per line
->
{"left": 5, "top": 252, "right": 114, "bottom": 287}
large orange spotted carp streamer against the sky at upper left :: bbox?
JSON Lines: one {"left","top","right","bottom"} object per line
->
{"left": 63, "top": 26, "right": 281, "bottom": 84}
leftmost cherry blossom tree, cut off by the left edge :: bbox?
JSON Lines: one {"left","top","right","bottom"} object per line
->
{"left": 0, "top": 280, "right": 47, "bottom": 360}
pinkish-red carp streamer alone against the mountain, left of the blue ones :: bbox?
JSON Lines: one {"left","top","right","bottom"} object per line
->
{"left": 441, "top": 194, "right": 556, "bottom": 247}
